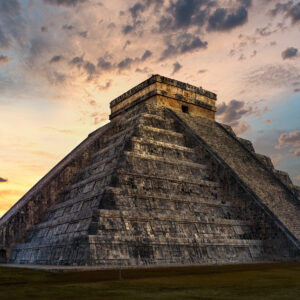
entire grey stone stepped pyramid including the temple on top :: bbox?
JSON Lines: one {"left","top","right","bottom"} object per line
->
{"left": 0, "top": 75, "right": 300, "bottom": 265}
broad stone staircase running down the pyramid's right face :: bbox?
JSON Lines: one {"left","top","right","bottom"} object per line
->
{"left": 172, "top": 112, "right": 300, "bottom": 249}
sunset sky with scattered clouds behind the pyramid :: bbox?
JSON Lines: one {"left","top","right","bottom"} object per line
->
{"left": 0, "top": 0, "right": 300, "bottom": 216}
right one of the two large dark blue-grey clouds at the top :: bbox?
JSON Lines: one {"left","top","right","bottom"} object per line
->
{"left": 207, "top": 6, "right": 248, "bottom": 31}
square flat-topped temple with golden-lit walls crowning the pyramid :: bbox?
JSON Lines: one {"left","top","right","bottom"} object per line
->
{"left": 110, "top": 75, "right": 217, "bottom": 120}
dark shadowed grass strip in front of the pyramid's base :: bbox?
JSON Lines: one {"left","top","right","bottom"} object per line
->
{"left": 0, "top": 263, "right": 300, "bottom": 300}
